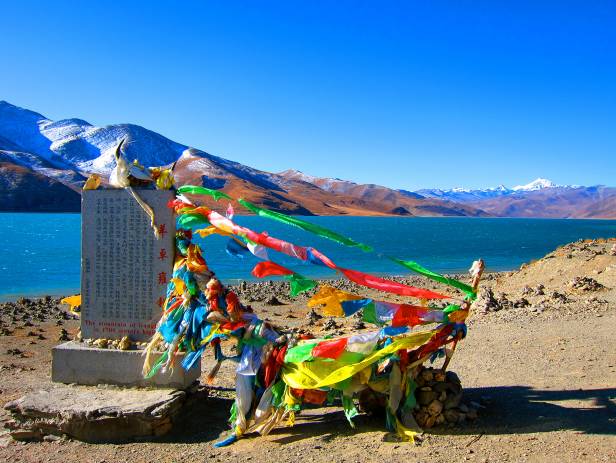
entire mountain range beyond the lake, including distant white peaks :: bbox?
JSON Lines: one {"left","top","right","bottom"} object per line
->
{"left": 0, "top": 101, "right": 616, "bottom": 217}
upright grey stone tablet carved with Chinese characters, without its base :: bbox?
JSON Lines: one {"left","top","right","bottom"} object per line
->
{"left": 81, "top": 189, "right": 175, "bottom": 341}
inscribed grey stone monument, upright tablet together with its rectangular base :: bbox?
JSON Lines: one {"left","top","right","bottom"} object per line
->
{"left": 52, "top": 189, "right": 200, "bottom": 388}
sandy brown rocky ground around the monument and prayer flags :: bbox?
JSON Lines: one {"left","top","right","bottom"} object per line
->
{"left": 0, "top": 240, "right": 616, "bottom": 463}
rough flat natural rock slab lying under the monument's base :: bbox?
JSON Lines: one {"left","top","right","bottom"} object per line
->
{"left": 4, "top": 384, "right": 203, "bottom": 443}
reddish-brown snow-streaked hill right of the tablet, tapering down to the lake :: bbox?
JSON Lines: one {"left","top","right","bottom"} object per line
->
{"left": 175, "top": 149, "right": 487, "bottom": 216}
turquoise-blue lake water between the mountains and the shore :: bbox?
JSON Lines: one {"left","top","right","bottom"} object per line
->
{"left": 0, "top": 213, "right": 616, "bottom": 300}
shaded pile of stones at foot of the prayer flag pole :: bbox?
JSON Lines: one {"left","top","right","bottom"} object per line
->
{"left": 413, "top": 367, "right": 481, "bottom": 429}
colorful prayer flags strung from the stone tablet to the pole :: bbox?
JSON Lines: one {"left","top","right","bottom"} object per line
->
{"left": 143, "top": 187, "right": 482, "bottom": 446}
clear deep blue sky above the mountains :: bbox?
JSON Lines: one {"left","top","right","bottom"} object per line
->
{"left": 0, "top": 0, "right": 616, "bottom": 189}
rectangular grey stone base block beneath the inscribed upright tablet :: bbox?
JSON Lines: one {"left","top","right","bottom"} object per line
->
{"left": 51, "top": 341, "right": 201, "bottom": 389}
